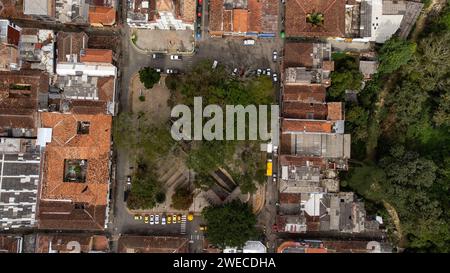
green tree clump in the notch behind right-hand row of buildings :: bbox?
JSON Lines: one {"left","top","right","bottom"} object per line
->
{"left": 327, "top": 53, "right": 363, "bottom": 100}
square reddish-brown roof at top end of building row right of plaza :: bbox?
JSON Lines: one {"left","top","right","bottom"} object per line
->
{"left": 283, "top": 43, "right": 314, "bottom": 68}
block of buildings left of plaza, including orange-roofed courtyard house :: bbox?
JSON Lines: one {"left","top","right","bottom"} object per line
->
{"left": 0, "top": 20, "right": 117, "bottom": 230}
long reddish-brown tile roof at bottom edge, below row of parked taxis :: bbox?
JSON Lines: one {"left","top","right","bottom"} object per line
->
{"left": 118, "top": 235, "right": 189, "bottom": 253}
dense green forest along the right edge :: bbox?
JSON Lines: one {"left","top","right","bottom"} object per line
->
{"left": 344, "top": 3, "right": 450, "bottom": 252}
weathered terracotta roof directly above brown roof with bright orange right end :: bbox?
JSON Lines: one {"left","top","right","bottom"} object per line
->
{"left": 283, "top": 84, "right": 327, "bottom": 103}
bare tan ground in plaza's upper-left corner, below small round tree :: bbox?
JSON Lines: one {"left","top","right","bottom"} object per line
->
{"left": 130, "top": 74, "right": 170, "bottom": 124}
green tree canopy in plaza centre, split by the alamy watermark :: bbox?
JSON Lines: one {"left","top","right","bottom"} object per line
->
{"left": 173, "top": 61, "right": 274, "bottom": 193}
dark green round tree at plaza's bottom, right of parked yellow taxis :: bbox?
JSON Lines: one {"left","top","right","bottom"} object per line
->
{"left": 202, "top": 201, "right": 258, "bottom": 248}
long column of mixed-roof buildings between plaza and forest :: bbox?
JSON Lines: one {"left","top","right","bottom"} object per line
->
{"left": 275, "top": 42, "right": 378, "bottom": 233}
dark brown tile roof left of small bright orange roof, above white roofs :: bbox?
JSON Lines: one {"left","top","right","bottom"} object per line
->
{"left": 56, "top": 31, "right": 89, "bottom": 62}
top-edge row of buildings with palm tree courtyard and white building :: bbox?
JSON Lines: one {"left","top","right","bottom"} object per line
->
{"left": 208, "top": 0, "right": 423, "bottom": 43}
